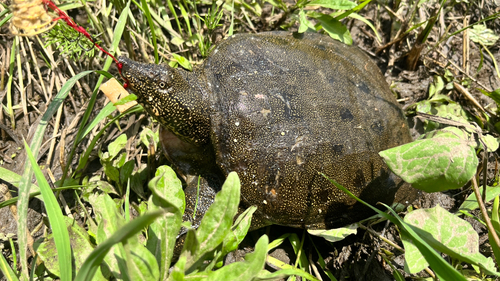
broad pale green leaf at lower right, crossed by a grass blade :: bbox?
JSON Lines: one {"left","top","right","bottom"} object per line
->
{"left": 402, "top": 205, "right": 496, "bottom": 274}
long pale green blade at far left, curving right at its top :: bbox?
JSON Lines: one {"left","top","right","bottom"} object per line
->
{"left": 17, "top": 70, "right": 92, "bottom": 280}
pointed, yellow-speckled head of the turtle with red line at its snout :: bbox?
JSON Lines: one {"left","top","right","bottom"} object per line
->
{"left": 118, "top": 57, "right": 210, "bottom": 145}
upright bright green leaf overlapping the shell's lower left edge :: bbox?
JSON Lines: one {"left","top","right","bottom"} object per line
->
{"left": 188, "top": 172, "right": 240, "bottom": 267}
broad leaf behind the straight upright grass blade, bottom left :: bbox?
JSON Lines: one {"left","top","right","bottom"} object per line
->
{"left": 37, "top": 217, "right": 107, "bottom": 280}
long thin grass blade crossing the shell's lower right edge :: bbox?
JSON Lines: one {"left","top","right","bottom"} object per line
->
{"left": 322, "top": 174, "right": 466, "bottom": 281}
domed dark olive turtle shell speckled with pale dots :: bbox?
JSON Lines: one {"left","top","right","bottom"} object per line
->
{"left": 200, "top": 32, "right": 416, "bottom": 228}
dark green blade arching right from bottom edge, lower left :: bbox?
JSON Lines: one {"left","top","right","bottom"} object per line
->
{"left": 75, "top": 210, "right": 164, "bottom": 281}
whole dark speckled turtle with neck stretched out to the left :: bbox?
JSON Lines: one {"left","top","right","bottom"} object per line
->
{"left": 119, "top": 31, "right": 416, "bottom": 229}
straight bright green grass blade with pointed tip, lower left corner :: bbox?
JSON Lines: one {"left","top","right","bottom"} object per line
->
{"left": 24, "top": 142, "right": 73, "bottom": 281}
